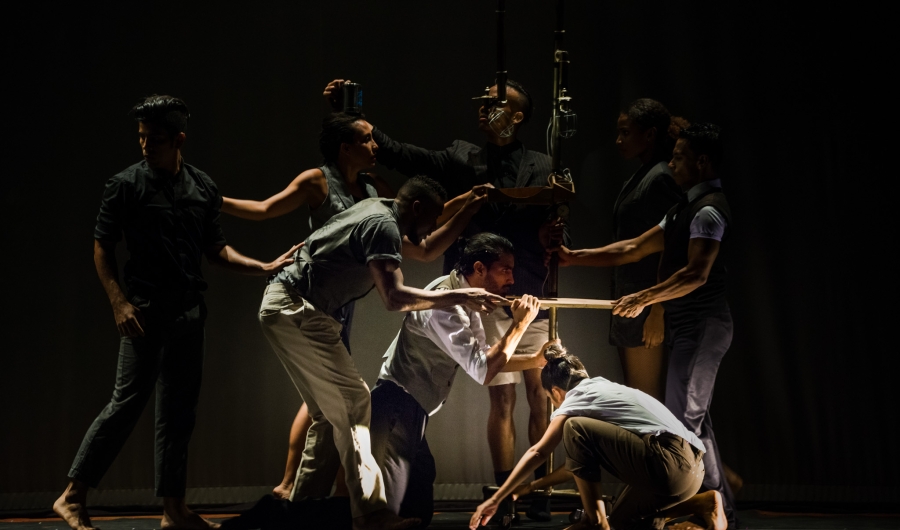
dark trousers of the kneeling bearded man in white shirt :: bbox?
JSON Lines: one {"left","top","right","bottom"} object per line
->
{"left": 369, "top": 379, "right": 437, "bottom": 528}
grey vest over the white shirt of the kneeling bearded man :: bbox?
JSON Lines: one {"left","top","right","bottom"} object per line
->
{"left": 379, "top": 271, "right": 459, "bottom": 416}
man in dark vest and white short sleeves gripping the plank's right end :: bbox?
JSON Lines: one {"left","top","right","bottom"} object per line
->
{"left": 558, "top": 123, "right": 736, "bottom": 527}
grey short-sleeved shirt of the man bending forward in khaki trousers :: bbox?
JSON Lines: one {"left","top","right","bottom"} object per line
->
{"left": 269, "top": 199, "right": 403, "bottom": 315}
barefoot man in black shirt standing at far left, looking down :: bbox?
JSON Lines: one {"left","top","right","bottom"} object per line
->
{"left": 53, "top": 96, "right": 299, "bottom": 530}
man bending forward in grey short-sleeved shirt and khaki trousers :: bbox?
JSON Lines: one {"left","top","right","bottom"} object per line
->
{"left": 259, "top": 176, "right": 504, "bottom": 530}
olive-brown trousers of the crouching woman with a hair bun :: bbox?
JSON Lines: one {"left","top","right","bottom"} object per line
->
{"left": 563, "top": 417, "right": 704, "bottom": 530}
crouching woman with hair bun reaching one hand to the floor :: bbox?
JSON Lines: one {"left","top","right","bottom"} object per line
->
{"left": 469, "top": 344, "right": 727, "bottom": 530}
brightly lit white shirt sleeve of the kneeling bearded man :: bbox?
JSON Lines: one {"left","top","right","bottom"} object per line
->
{"left": 416, "top": 306, "right": 490, "bottom": 385}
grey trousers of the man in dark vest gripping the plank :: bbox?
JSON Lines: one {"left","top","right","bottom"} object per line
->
{"left": 666, "top": 309, "right": 736, "bottom": 528}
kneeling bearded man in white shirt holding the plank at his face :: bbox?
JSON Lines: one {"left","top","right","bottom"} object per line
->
{"left": 370, "top": 233, "right": 546, "bottom": 528}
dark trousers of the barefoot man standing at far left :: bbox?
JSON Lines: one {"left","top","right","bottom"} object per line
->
{"left": 69, "top": 295, "right": 206, "bottom": 497}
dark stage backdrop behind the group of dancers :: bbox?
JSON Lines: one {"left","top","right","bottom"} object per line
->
{"left": 0, "top": 0, "right": 900, "bottom": 503}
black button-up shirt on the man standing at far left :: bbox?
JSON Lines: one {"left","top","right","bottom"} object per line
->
{"left": 94, "top": 161, "right": 226, "bottom": 298}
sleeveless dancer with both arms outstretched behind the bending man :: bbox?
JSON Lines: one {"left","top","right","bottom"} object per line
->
{"left": 222, "top": 113, "right": 486, "bottom": 499}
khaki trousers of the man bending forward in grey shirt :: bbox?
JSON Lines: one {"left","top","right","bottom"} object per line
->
{"left": 259, "top": 283, "right": 387, "bottom": 517}
